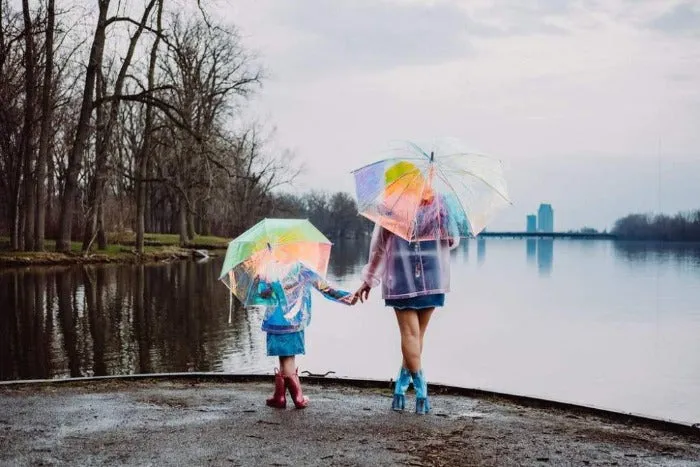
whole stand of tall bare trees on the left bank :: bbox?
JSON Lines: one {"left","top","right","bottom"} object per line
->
{"left": 0, "top": 0, "right": 297, "bottom": 252}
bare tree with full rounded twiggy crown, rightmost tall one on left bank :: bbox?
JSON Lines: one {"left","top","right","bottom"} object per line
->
{"left": 154, "top": 15, "right": 262, "bottom": 244}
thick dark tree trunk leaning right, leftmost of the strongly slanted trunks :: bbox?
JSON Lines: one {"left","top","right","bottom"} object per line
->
{"left": 56, "top": 0, "right": 110, "bottom": 253}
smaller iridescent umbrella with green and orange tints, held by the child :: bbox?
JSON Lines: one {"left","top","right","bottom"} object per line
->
{"left": 219, "top": 219, "right": 331, "bottom": 319}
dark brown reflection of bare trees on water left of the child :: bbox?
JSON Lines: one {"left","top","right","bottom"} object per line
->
{"left": 0, "top": 261, "right": 245, "bottom": 380}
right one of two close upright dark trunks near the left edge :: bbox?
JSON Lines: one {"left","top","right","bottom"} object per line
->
{"left": 34, "top": 0, "right": 55, "bottom": 251}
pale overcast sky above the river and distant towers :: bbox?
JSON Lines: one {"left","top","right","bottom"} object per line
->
{"left": 213, "top": 0, "right": 700, "bottom": 230}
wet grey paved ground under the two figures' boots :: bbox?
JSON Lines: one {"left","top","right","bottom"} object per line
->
{"left": 0, "top": 377, "right": 700, "bottom": 466}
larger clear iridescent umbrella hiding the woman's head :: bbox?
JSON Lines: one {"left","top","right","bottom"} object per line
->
{"left": 353, "top": 140, "right": 511, "bottom": 241}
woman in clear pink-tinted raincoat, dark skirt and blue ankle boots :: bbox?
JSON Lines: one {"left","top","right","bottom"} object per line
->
{"left": 355, "top": 191, "right": 459, "bottom": 414}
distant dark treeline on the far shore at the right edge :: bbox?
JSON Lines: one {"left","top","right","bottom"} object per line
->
{"left": 612, "top": 210, "right": 700, "bottom": 242}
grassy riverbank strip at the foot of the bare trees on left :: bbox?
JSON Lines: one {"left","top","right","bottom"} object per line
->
{"left": 0, "top": 233, "right": 230, "bottom": 267}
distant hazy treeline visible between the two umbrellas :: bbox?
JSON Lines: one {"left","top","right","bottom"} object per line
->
{"left": 269, "top": 191, "right": 374, "bottom": 239}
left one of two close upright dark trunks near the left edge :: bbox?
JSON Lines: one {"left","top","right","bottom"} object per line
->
{"left": 22, "top": 0, "right": 36, "bottom": 251}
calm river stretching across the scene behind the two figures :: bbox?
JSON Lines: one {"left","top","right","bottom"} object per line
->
{"left": 0, "top": 238, "right": 700, "bottom": 423}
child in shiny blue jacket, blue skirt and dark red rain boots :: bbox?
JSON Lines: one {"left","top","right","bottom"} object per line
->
{"left": 248, "top": 262, "right": 357, "bottom": 409}
